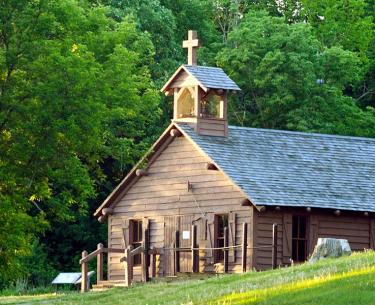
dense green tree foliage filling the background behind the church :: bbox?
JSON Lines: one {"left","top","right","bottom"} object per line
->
{"left": 0, "top": 0, "right": 375, "bottom": 288}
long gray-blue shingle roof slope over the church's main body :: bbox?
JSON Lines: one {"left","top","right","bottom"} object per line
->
{"left": 178, "top": 123, "right": 375, "bottom": 212}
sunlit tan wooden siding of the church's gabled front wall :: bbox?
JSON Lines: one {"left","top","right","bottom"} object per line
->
{"left": 108, "top": 137, "right": 252, "bottom": 280}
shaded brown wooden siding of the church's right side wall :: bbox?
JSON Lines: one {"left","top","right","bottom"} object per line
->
{"left": 251, "top": 207, "right": 375, "bottom": 270}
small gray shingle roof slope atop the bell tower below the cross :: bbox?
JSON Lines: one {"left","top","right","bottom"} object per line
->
{"left": 184, "top": 65, "right": 241, "bottom": 90}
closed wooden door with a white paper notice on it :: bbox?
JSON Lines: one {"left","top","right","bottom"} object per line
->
{"left": 179, "top": 215, "right": 194, "bottom": 272}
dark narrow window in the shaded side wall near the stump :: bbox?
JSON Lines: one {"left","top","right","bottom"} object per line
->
{"left": 292, "top": 216, "right": 307, "bottom": 262}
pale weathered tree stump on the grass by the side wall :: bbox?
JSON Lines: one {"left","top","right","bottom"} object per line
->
{"left": 309, "top": 238, "right": 352, "bottom": 263}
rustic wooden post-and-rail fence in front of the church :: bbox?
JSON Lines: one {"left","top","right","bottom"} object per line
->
{"left": 79, "top": 223, "right": 277, "bottom": 292}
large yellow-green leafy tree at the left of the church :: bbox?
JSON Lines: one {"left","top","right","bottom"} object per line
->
{"left": 0, "top": 0, "right": 160, "bottom": 282}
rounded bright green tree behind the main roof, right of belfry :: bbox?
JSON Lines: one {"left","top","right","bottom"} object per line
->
{"left": 218, "top": 12, "right": 375, "bottom": 135}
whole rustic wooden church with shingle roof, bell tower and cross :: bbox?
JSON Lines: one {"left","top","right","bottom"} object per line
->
{"left": 95, "top": 31, "right": 375, "bottom": 281}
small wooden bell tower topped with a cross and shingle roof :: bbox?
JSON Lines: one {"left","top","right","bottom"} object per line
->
{"left": 161, "top": 31, "right": 240, "bottom": 137}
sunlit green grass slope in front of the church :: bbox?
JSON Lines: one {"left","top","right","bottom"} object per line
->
{"left": 0, "top": 251, "right": 375, "bottom": 305}
